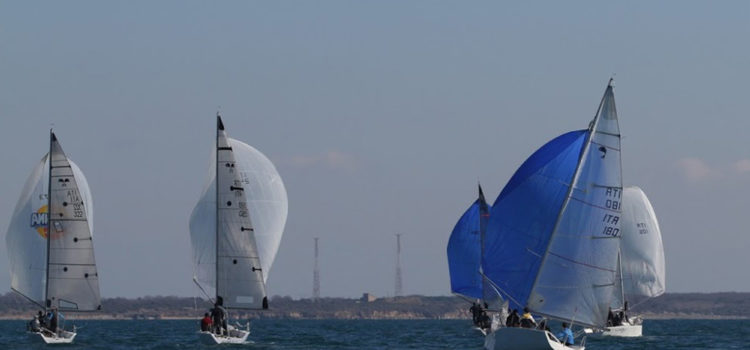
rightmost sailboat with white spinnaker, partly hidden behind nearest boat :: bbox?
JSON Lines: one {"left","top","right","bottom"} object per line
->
{"left": 602, "top": 186, "right": 665, "bottom": 337}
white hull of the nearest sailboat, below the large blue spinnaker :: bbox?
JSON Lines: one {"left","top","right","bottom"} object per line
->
{"left": 484, "top": 327, "right": 584, "bottom": 350}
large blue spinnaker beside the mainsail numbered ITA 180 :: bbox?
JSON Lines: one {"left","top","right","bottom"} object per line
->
{"left": 482, "top": 130, "right": 588, "bottom": 309}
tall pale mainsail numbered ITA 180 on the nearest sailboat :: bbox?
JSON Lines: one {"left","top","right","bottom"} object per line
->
{"left": 528, "top": 85, "right": 622, "bottom": 327}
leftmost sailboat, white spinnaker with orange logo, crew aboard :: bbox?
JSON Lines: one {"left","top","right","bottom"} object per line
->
{"left": 5, "top": 131, "right": 101, "bottom": 344}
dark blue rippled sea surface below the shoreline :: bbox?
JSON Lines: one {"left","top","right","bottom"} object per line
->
{"left": 0, "top": 320, "right": 750, "bottom": 350}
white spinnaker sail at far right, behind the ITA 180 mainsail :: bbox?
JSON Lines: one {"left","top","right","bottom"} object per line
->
{"left": 620, "top": 186, "right": 665, "bottom": 305}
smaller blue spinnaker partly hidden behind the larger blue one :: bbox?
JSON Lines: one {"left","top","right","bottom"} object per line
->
{"left": 447, "top": 187, "right": 490, "bottom": 299}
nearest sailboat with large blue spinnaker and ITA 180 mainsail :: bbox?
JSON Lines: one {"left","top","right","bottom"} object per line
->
{"left": 482, "top": 80, "right": 622, "bottom": 349}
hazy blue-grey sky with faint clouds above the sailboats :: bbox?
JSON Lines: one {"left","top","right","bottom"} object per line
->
{"left": 0, "top": 1, "right": 750, "bottom": 298}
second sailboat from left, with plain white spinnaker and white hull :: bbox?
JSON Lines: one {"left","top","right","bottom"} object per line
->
{"left": 190, "top": 115, "right": 288, "bottom": 344}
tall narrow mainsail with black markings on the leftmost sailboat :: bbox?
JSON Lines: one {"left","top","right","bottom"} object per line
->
{"left": 47, "top": 134, "right": 101, "bottom": 311}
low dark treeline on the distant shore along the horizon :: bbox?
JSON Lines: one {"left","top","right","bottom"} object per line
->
{"left": 0, "top": 293, "right": 750, "bottom": 319}
